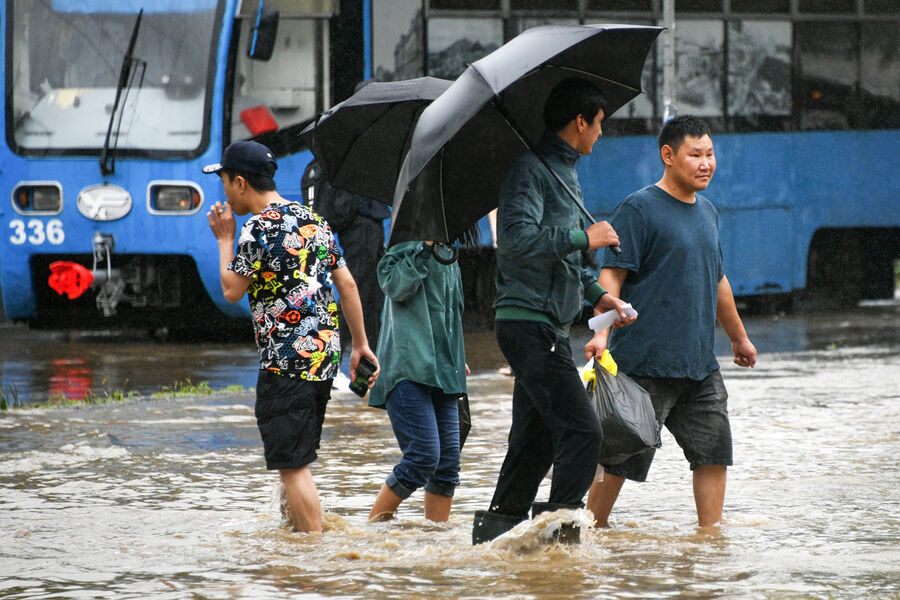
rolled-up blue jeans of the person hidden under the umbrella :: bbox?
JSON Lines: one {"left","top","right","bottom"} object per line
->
{"left": 385, "top": 380, "right": 459, "bottom": 499}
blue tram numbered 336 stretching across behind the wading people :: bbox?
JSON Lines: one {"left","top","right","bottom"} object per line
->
{"left": 0, "top": 0, "right": 900, "bottom": 329}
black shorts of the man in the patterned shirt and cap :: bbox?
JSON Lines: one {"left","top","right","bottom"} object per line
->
{"left": 256, "top": 370, "right": 332, "bottom": 471}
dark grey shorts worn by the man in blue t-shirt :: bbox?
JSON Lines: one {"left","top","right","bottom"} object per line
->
{"left": 603, "top": 371, "right": 732, "bottom": 481}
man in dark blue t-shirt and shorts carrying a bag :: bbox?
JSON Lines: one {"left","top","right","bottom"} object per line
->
{"left": 587, "top": 115, "right": 756, "bottom": 527}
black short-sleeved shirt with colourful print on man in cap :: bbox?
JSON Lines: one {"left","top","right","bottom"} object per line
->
{"left": 228, "top": 202, "right": 346, "bottom": 381}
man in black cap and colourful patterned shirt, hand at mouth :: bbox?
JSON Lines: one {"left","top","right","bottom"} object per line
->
{"left": 203, "top": 141, "right": 378, "bottom": 532}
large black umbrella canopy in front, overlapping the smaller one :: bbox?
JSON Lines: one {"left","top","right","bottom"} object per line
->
{"left": 389, "top": 25, "right": 662, "bottom": 244}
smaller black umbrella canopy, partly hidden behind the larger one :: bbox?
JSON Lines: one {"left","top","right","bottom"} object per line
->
{"left": 300, "top": 77, "right": 451, "bottom": 204}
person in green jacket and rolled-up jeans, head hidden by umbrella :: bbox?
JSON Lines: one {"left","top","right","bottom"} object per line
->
{"left": 369, "top": 241, "right": 468, "bottom": 522}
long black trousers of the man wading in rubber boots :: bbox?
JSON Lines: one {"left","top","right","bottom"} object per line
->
{"left": 490, "top": 321, "right": 603, "bottom": 518}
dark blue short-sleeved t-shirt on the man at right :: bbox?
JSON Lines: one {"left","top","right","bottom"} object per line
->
{"left": 603, "top": 185, "right": 725, "bottom": 381}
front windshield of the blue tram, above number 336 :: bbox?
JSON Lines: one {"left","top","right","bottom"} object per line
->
{"left": 6, "top": 0, "right": 218, "bottom": 155}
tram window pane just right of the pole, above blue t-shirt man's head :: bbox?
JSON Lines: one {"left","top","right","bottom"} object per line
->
{"left": 675, "top": 20, "right": 725, "bottom": 125}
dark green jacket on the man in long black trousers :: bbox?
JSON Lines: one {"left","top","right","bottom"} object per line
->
{"left": 494, "top": 131, "right": 606, "bottom": 334}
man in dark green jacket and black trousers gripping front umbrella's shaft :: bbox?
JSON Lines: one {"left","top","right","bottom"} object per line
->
{"left": 472, "top": 79, "right": 634, "bottom": 544}
